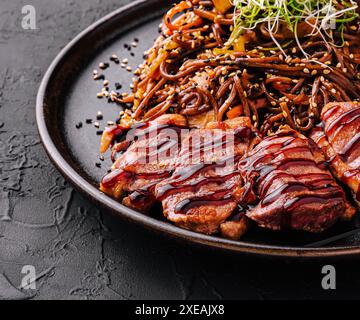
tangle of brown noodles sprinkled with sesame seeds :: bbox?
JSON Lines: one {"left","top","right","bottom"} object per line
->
{"left": 112, "top": 0, "right": 360, "bottom": 134}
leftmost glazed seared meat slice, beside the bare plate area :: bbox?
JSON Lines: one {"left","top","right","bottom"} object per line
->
{"left": 100, "top": 115, "right": 188, "bottom": 212}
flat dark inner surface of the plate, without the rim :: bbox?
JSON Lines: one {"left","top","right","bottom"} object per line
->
{"left": 47, "top": 3, "right": 360, "bottom": 249}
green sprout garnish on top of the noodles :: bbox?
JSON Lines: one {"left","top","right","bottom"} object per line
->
{"left": 227, "top": 0, "right": 358, "bottom": 57}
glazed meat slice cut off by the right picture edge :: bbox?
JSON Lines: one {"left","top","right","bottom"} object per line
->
{"left": 312, "top": 102, "right": 360, "bottom": 204}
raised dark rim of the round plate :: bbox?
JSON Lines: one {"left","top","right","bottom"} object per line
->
{"left": 36, "top": 0, "right": 360, "bottom": 258}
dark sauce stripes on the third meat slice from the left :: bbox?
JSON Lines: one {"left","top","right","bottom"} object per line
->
{"left": 239, "top": 132, "right": 343, "bottom": 210}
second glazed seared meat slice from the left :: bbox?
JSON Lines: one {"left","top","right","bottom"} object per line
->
{"left": 155, "top": 118, "right": 253, "bottom": 238}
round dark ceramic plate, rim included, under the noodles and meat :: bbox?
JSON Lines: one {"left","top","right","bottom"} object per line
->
{"left": 36, "top": 0, "right": 360, "bottom": 257}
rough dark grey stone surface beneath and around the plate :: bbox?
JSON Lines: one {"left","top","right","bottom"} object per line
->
{"left": 0, "top": 0, "right": 360, "bottom": 299}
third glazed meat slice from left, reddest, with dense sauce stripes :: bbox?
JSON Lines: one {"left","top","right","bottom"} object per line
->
{"left": 238, "top": 128, "right": 353, "bottom": 232}
